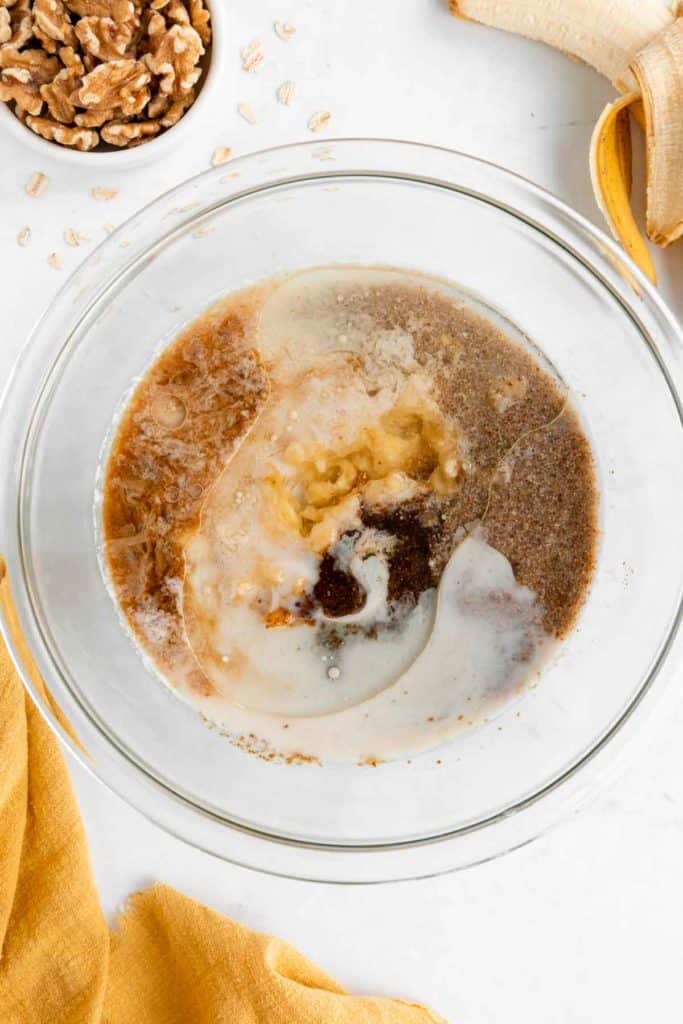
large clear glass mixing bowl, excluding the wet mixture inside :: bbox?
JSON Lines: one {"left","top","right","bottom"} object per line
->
{"left": 0, "top": 140, "right": 683, "bottom": 882}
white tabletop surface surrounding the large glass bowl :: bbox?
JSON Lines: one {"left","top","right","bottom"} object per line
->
{"left": 0, "top": 0, "right": 683, "bottom": 1024}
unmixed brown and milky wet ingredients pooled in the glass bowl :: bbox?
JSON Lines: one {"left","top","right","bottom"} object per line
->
{"left": 102, "top": 266, "right": 597, "bottom": 762}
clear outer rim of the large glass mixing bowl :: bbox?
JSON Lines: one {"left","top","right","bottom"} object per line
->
{"left": 0, "top": 138, "right": 683, "bottom": 882}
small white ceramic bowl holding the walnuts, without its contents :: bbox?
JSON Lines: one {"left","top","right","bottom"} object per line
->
{"left": 0, "top": 0, "right": 227, "bottom": 170}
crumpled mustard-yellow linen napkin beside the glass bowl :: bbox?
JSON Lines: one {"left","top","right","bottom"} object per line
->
{"left": 0, "top": 558, "right": 444, "bottom": 1024}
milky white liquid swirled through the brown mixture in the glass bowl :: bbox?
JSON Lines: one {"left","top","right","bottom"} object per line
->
{"left": 173, "top": 269, "right": 553, "bottom": 761}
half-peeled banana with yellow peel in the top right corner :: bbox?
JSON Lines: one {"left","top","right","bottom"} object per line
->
{"left": 449, "top": 0, "right": 683, "bottom": 282}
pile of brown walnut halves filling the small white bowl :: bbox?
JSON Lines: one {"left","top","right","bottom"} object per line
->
{"left": 0, "top": 0, "right": 210, "bottom": 150}
